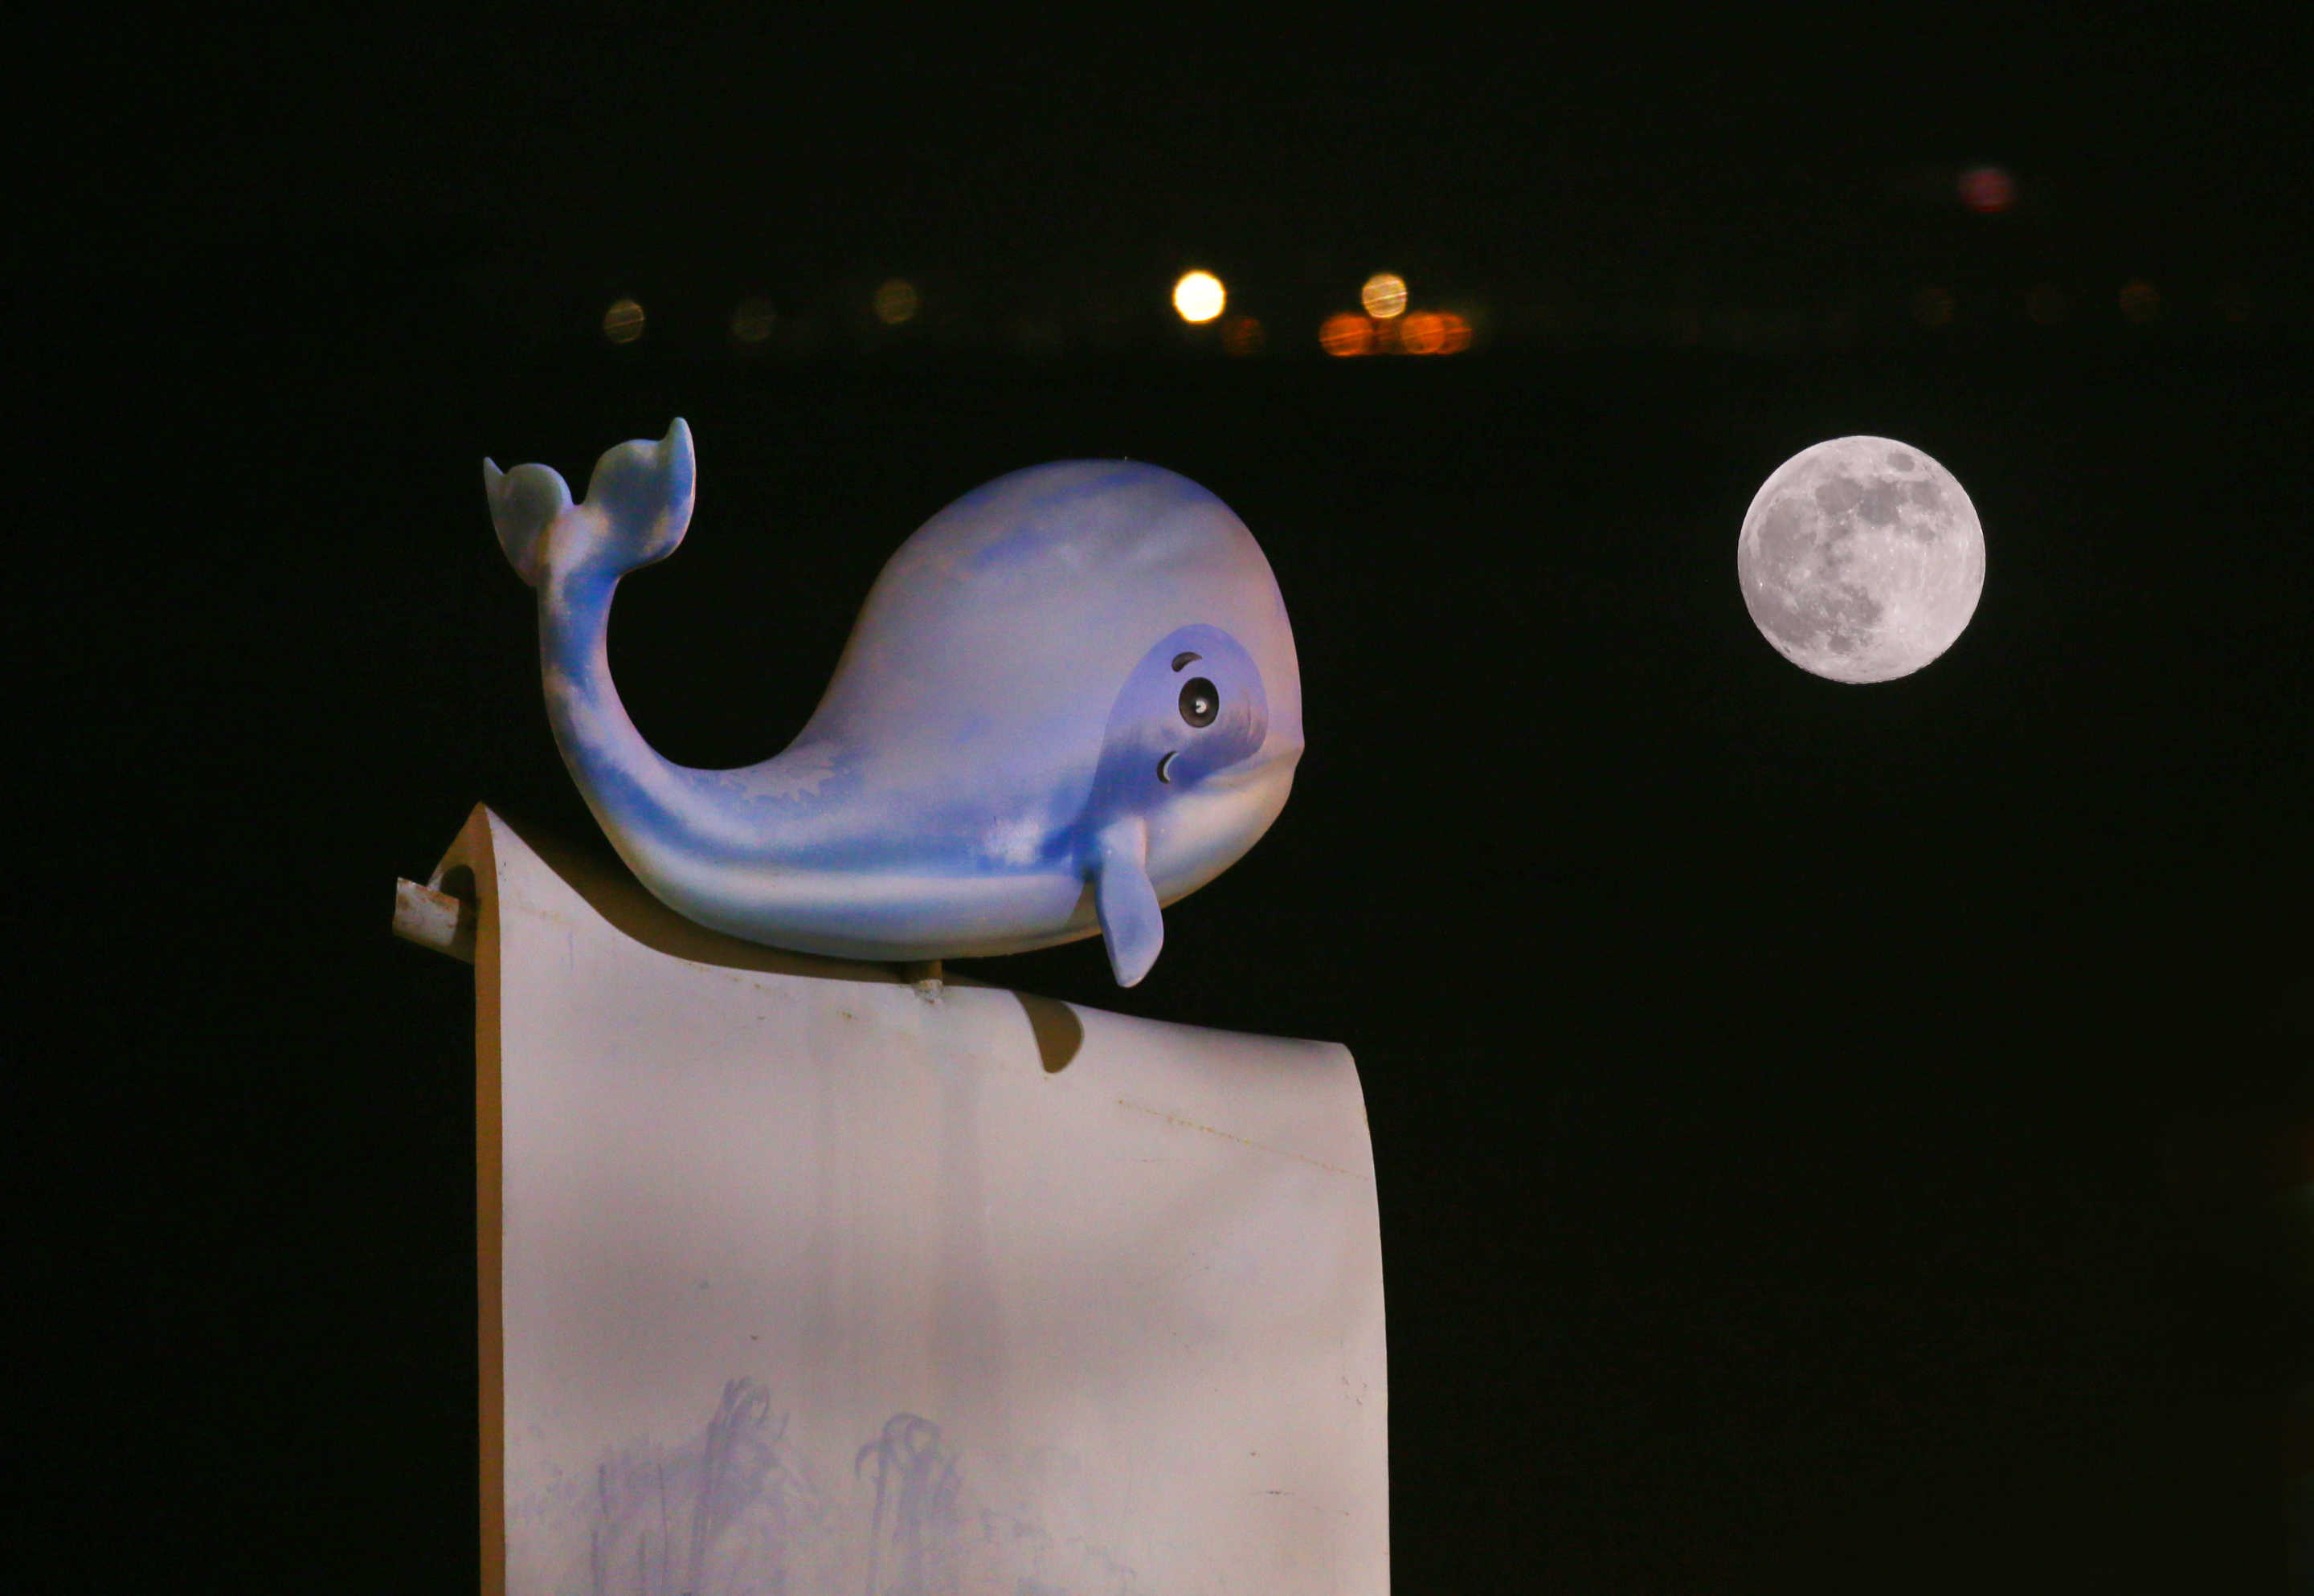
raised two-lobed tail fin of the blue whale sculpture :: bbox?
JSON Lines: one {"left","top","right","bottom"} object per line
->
{"left": 481, "top": 416, "right": 699, "bottom": 587}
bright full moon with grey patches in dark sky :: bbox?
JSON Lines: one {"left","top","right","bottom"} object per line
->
{"left": 1736, "top": 437, "right": 1985, "bottom": 683}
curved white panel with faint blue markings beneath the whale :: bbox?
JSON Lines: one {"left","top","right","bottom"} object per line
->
{"left": 425, "top": 810, "right": 1388, "bottom": 1596}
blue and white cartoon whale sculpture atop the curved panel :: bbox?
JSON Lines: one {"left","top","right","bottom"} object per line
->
{"left": 484, "top": 418, "right": 1302, "bottom": 986}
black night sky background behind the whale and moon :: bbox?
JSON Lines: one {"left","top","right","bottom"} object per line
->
{"left": 22, "top": 10, "right": 2314, "bottom": 1591}
